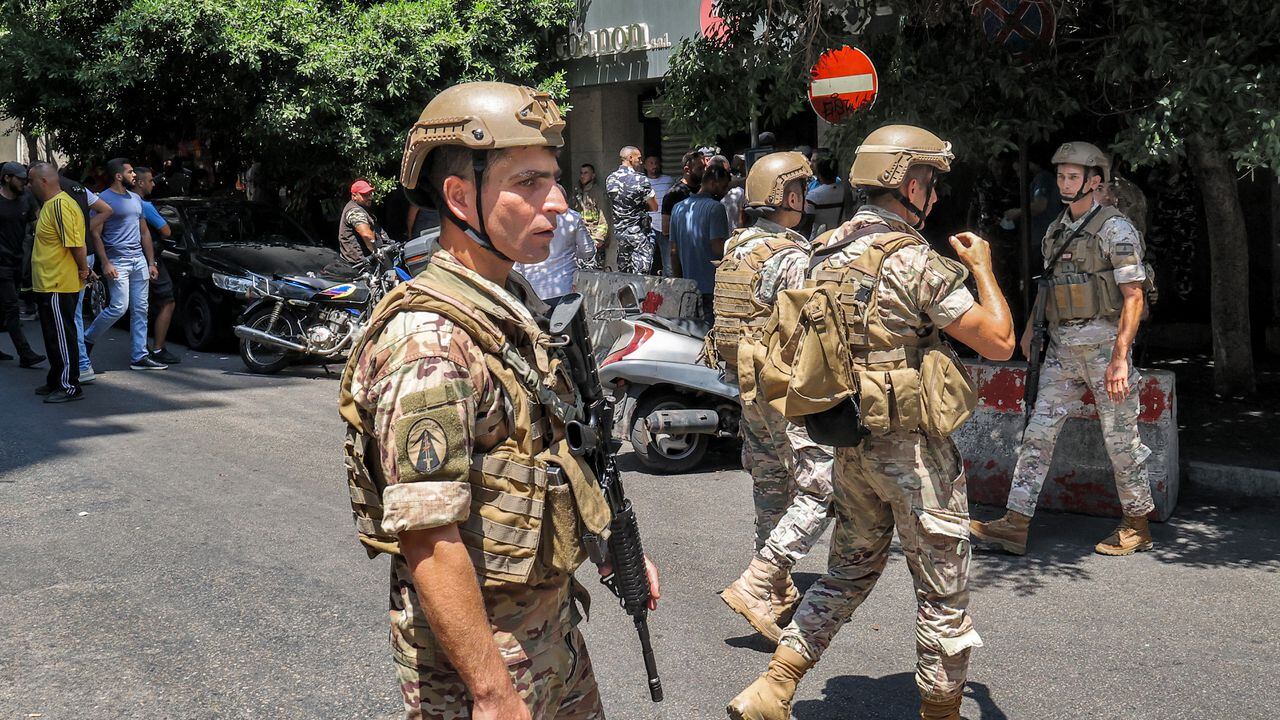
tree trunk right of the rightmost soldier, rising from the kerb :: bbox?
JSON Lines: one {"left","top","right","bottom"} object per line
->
{"left": 1187, "top": 135, "right": 1254, "bottom": 396}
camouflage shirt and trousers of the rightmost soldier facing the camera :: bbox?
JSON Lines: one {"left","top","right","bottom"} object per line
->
{"left": 1007, "top": 202, "right": 1155, "bottom": 518}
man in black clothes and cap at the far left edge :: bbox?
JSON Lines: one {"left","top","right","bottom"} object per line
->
{"left": 0, "top": 163, "right": 45, "bottom": 368}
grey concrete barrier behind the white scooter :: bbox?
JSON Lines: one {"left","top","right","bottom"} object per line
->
{"left": 573, "top": 270, "right": 700, "bottom": 356}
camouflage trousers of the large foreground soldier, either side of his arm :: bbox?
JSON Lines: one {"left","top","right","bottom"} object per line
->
{"left": 396, "top": 628, "right": 604, "bottom": 720}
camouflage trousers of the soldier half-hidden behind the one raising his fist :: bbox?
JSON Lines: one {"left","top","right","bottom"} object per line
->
{"left": 726, "top": 373, "right": 833, "bottom": 568}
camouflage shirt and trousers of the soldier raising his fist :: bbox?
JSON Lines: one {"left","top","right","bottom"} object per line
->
{"left": 781, "top": 206, "right": 982, "bottom": 701}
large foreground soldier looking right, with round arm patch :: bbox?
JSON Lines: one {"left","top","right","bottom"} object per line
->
{"left": 340, "top": 82, "right": 658, "bottom": 720}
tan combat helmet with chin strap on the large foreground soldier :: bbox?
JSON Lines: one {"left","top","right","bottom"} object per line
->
{"left": 401, "top": 82, "right": 564, "bottom": 261}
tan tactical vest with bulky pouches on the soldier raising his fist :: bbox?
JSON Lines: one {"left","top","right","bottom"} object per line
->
{"left": 762, "top": 232, "right": 977, "bottom": 437}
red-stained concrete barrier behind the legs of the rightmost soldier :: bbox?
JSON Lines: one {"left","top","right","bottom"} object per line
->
{"left": 955, "top": 361, "right": 1179, "bottom": 521}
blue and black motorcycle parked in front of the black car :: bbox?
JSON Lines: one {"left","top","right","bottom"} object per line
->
{"left": 236, "top": 241, "right": 410, "bottom": 374}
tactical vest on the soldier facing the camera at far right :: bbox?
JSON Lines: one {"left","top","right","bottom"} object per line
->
{"left": 1043, "top": 205, "right": 1156, "bottom": 323}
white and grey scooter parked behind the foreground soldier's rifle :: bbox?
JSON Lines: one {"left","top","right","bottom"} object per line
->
{"left": 596, "top": 286, "right": 742, "bottom": 474}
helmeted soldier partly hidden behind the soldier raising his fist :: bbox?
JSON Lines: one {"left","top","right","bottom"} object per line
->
{"left": 708, "top": 152, "right": 832, "bottom": 643}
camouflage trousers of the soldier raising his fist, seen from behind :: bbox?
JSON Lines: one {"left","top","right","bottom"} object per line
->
{"left": 781, "top": 432, "right": 982, "bottom": 701}
